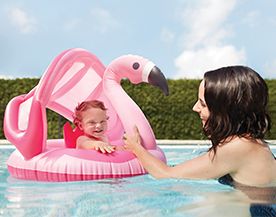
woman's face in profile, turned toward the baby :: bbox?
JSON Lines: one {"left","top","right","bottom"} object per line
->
{"left": 193, "top": 80, "right": 210, "bottom": 126}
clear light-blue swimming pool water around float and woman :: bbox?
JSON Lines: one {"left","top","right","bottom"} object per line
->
{"left": 0, "top": 146, "right": 276, "bottom": 217}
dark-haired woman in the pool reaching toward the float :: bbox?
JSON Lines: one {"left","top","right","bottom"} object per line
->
{"left": 124, "top": 66, "right": 276, "bottom": 187}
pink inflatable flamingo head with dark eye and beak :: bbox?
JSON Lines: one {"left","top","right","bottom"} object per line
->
{"left": 105, "top": 55, "right": 169, "bottom": 96}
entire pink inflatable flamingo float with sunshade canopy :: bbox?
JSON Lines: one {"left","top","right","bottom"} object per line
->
{"left": 4, "top": 48, "right": 168, "bottom": 182}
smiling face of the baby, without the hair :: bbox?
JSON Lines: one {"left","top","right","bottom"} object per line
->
{"left": 80, "top": 108, "right": 108, "bottom": 138}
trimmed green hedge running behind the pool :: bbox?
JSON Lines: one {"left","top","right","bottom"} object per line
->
{"left": 0, "top": 78, "right": 276, "bottom": 139}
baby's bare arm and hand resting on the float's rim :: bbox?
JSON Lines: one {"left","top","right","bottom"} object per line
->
{"left": 76, "top": 136, "right": 115, "bottom": 153}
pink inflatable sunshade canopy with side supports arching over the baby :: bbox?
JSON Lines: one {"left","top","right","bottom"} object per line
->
{"left": 4, "top": 48, "right": 123, "bottom": 158}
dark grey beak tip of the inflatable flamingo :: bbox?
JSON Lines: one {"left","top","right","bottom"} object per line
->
{"left": 148, "top": 66, "right": 169, "bottom": 96}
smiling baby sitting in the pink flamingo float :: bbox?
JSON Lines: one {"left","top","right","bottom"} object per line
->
{"left": 73, "top": 100, "right": 115, "bottom": 153}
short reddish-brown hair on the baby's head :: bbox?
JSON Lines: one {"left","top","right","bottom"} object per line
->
{"left": 73, "top": 100, "right": 107, "bottom": 127}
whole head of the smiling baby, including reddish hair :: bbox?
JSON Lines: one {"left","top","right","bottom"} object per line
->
{"left": 73, "top": 100, "right": 108, "bottom": 137}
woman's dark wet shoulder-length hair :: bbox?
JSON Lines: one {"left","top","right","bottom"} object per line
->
{"left": 203, "top": 66, "right": 271, "bottom": 153}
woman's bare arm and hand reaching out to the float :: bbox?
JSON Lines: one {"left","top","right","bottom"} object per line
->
{"left": 124, "top": 127, "right": 242, "bottom": 179}
